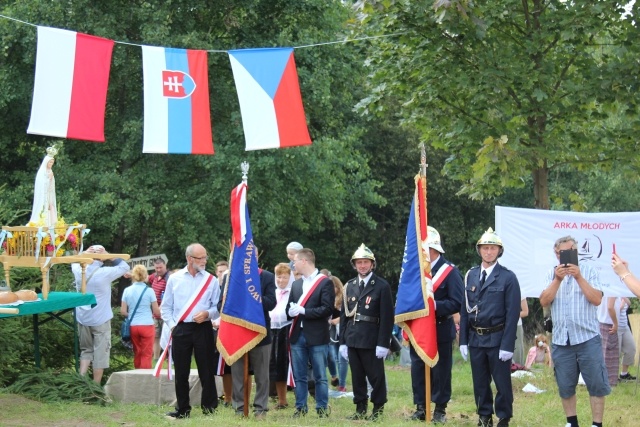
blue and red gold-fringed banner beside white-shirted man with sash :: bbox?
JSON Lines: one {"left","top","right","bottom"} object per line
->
{"left": 217, "top": 182, "right": 267, "bottom": 365}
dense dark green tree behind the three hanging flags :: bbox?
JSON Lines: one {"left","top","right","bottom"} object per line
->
{"left": 0, "top": 0, "right": 385, "bottom": 274}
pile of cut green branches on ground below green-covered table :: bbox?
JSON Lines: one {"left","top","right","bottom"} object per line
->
{"left": 4, "top": 371, "right": 109, "bottom": 405}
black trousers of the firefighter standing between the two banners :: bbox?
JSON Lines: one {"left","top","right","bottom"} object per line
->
{"left": 349, "top": 347, "right": 387, "bottom": 405}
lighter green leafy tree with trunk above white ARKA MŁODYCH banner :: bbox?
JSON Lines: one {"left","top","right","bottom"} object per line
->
{"left": 359, "top": 0, "right": 640, "bottom": 209}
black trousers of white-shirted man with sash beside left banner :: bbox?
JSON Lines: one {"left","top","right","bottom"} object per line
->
{"left": 171, "top": 321, "right": 218, "bottom": 413}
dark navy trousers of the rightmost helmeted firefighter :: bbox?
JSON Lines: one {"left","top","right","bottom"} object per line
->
{"left": 469, "top": 347, "right": 513, "bottom": 418}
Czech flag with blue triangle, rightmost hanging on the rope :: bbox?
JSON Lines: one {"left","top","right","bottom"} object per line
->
{"left": 229, "top": 48, "right": 311, "bottom": 151}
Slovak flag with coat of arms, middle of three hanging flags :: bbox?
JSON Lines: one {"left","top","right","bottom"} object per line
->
{"left": 142, "top": 46, "right": 213, "bottom": 154}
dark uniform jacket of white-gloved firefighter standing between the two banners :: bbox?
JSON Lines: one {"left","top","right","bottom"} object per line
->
{"left": 340, "top": 273, "right": 393, "bottom": 349}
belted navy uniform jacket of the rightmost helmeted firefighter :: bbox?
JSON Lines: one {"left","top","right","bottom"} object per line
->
{"left": 460, "top": 263, "right": 520, "bottom": 352}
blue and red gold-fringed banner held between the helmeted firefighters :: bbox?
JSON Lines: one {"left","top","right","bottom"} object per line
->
{"left": 395, "top": 175, "right": 438, "bottom": 367}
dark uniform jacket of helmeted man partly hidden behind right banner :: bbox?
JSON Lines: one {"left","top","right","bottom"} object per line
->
{"left": 431, "top": 255, "right": 464, "bottom": 343}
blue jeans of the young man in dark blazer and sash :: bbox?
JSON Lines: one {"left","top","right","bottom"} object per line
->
{"left": 291, "top": 331, "right": 329, "bottom": 410}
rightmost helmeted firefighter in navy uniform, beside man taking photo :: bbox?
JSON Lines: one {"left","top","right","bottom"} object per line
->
{"left": 460, "top": 228, "right": 520, "bottom": 427}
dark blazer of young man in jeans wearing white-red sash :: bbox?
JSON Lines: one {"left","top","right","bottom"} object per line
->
{"left": 286, "top": 277, "right": 336, "bottom": 345}
